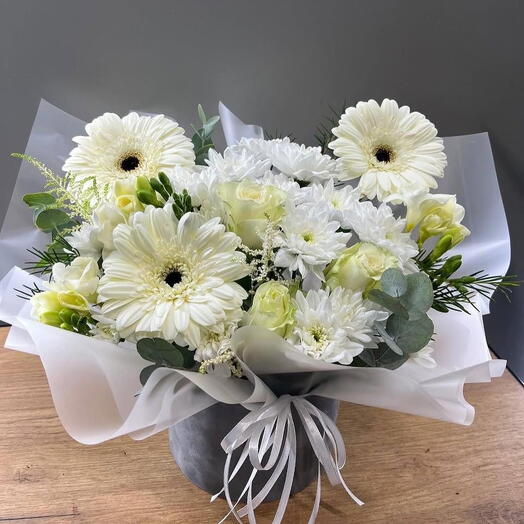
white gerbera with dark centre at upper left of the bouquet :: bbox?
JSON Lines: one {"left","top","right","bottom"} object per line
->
{"left": 62, "top": 113, "right": 195, "bottom": 198}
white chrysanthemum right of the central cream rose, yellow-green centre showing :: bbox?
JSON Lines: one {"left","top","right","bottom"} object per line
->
{"left": 275, "top": 206, "right": 351, "bottom": 287}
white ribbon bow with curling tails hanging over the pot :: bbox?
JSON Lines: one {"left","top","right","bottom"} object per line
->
{"left": 211, "top": 395, "right": 364, "bottom": 524}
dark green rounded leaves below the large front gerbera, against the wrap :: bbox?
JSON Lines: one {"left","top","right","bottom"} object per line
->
{"left": 136, "top": 338, "right": 199, "bottom": 385}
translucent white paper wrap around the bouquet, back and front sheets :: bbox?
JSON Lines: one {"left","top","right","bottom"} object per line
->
{"left": 0, "top": 101, "right": 510, "bottom": 444}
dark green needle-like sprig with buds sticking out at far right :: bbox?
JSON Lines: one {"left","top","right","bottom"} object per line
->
{"left": 415, "top": 250, "right": 519, "bottom": 314}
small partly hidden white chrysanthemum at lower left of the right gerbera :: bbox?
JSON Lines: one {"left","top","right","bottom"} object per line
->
{"left": 303, "top": 179, "right": 359, "bottom": 229}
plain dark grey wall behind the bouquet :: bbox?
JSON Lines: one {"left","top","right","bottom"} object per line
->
{"left": 0, "top": 0, "right": 524, "bottom": 375}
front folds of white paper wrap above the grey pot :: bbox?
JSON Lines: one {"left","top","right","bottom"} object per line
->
{"left": 0, "top": 268, "right": 505, "bottom": 444}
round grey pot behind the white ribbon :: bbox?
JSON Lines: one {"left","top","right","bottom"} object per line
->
{"left": 169, "top": 373, "right": 339, "bottom": 502}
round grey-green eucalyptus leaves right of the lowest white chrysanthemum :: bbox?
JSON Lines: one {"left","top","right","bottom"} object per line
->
{"left": 359, "top": 268, "right": 433, "bottom": 369}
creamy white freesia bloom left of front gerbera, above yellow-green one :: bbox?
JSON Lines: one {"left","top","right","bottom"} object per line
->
{"left": 49, "top": 257, "right": 100, "bottom": 302}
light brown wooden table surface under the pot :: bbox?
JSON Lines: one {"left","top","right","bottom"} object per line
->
{"left": 0, "top": 328, "right": 524, "bottom": 524}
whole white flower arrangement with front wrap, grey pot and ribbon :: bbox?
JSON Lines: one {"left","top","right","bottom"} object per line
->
{"left": 0, "top": 99, "right": 515, "bottom": 522}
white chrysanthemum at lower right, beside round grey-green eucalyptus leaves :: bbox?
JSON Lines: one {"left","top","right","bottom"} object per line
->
{"left": 290, "top": 287, "right": 383, "bottom": 365}
